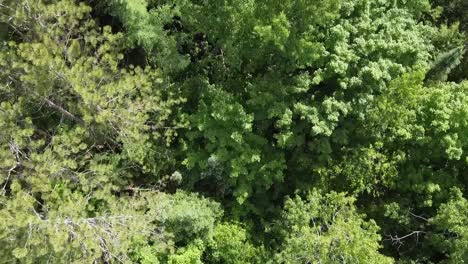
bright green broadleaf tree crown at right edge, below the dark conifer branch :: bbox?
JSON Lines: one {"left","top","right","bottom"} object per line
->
{"left": 319, "top": 71, "right": 468, "bottom": 199}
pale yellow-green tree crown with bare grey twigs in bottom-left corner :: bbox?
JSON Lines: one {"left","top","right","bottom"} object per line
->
{"left": 0, "top": 182, "right": 148, "bottom": 263}
